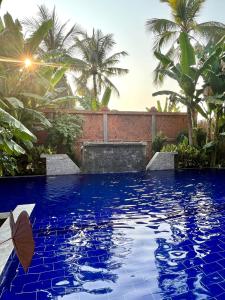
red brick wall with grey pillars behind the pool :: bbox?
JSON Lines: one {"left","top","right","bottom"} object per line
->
{"left": 38, "top": 109, "right": 187, "bottom": 160}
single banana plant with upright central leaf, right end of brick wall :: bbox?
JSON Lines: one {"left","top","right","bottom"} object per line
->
{"left": 153, "top": 32, "right": 223, "bottom": 145}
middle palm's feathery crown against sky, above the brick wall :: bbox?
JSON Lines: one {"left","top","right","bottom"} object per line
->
{"left": 75, "top": 29, "right": 128, "bottom": 100}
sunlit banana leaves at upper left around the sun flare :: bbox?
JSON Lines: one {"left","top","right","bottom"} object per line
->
{"left": 0, "top": 14, "right": 81, "bottom": 129}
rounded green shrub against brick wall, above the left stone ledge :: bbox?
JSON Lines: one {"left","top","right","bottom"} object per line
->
{"left": 47, "top": 115, "right": 83, "bottom": 155}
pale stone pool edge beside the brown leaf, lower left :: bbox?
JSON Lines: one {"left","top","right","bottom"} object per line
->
{"left": 0, "top": 204, "right": 35, "bottom": 276}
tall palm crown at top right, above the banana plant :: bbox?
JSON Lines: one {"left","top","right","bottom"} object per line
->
{"left": 146, "top": 0, "right": 225, "bottom": 83}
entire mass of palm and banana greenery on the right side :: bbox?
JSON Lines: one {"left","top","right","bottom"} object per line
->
{"left": 147, "top": 0, "right": 225, "bottom": 167}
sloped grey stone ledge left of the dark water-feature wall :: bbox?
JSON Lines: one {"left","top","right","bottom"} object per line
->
{"left": 41, "top": 154, "right": 80, "bottom": 176}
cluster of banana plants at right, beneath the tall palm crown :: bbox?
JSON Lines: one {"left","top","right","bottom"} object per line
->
{"left": 153, "top": 33, "right": 225, "bottom": 161}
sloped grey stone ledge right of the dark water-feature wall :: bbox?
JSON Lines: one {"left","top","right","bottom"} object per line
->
{"left": 146, "top": 152, "right": 177, "bottom": 171}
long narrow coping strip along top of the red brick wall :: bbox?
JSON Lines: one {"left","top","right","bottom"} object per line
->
{"left": 41, "top": 108, "right": 187, "bottom": 116}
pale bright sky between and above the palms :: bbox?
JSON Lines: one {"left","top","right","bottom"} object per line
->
{"left": 1, "top": 0, "right": 225, "bottom": 111}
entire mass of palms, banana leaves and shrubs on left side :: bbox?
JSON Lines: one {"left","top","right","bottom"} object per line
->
{"left": 0, "top": 1, "right": 127, "bottom": 175}
